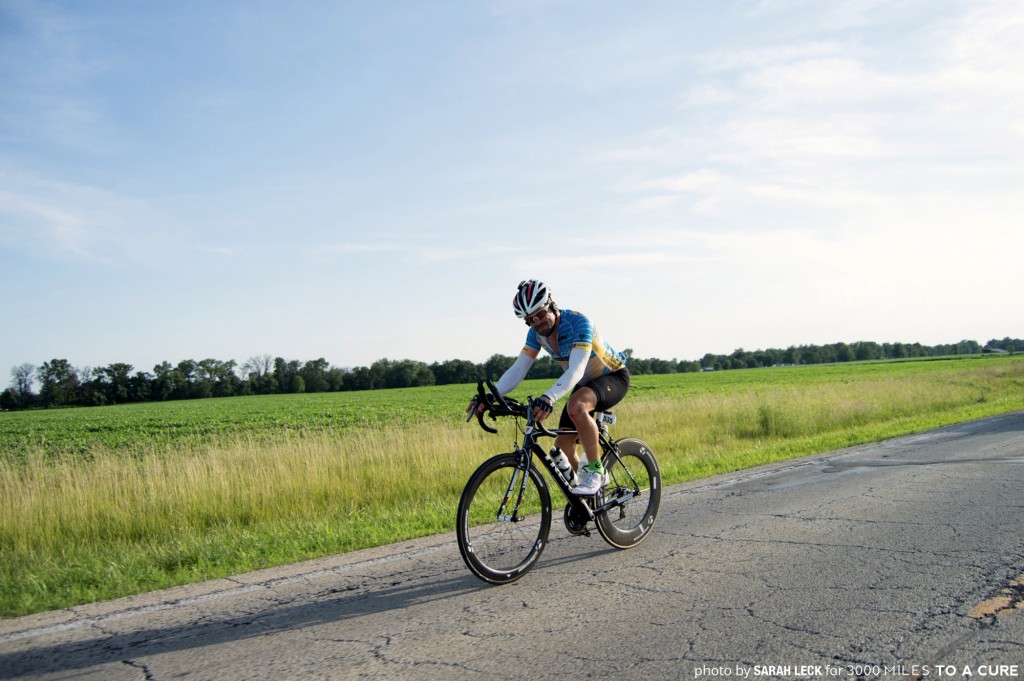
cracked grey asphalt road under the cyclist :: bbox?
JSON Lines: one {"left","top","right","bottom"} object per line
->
{"left": 0, "top": 413, "right": 1024, "bottom": 681}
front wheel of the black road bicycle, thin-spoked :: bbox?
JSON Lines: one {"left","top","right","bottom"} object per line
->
{"left": 456, "top": 454, "right": 552, "bottom": 584}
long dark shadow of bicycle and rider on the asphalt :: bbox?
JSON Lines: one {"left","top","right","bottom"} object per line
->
{"left": 0, "top": 547, "right": 614, "bottom": 679}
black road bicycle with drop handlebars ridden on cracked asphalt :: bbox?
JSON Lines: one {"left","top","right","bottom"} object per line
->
{"left": 456, "top": 381, "right": 662, "bottom": 584}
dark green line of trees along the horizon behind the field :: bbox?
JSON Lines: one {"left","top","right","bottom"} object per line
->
{"left": 0, "top": 338, "right": 1024, "bottom": 411}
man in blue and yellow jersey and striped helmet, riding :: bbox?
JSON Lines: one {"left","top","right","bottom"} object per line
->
{"left": 478, "top": 280, "right": 630, "bottom": 495}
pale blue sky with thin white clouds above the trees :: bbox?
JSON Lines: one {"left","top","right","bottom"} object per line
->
{"left": 0, "top": 0, "right": 1024, "bottom": 376}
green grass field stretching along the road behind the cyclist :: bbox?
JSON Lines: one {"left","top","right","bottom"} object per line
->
{"left": 0, "top": 356, "right": 1024, "bottom": 616}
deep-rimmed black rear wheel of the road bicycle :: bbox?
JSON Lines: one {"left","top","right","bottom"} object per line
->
{"left": 594, "top": 438, "right": 662, "bottom": 549}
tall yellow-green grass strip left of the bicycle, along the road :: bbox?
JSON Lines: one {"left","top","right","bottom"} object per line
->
{"left": 0, "top": 425, "right": 487, "bottom": 616}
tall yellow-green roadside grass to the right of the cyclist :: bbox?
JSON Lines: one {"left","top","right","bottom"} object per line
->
{"left": 616, "top": 361, "right": 1024, "bottom": 483}
